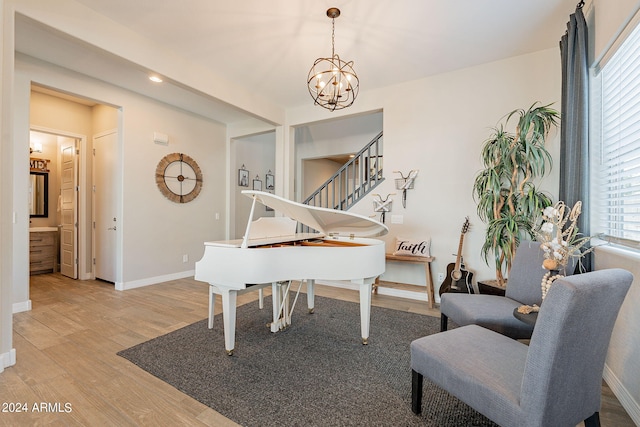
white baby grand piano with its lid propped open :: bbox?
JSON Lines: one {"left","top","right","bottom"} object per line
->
{"left": 195, "top": 190, "right": 388, "bottom": 355}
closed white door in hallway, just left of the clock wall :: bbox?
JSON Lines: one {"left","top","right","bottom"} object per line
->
{"left": 93, "top": 132, "right": 118, "bottom": 283}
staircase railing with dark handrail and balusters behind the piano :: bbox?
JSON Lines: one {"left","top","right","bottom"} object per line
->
{"left": 302, "top": 132, "right": 384, "bottom": 214}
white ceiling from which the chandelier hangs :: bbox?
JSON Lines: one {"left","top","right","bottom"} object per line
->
{"left": 16, "top": 0, "right": 577, "bottom": 122}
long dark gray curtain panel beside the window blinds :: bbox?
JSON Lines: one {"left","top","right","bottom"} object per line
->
{"left": 558, "top": 2, "right": 591, "bottom": 271}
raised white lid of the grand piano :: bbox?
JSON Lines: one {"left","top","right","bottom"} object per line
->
{"left": 242, "top": 190, "right": 389, "bottom": 237}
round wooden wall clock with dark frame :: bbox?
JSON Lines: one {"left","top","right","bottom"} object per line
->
{"left": 156, "top": 153, "right": 202, "bottom": 203}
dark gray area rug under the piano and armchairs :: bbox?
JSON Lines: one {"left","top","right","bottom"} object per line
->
{"left": 118, "top": 296, "right": 495, "bottom": 427}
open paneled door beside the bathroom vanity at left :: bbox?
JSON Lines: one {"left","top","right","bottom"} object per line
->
{"left": 58, "top": 137, "right": 78, "bottom": 279}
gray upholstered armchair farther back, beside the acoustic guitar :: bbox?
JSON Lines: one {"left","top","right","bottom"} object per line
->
{"left": 440, "top": 240, "right": 575, "bottom": 339}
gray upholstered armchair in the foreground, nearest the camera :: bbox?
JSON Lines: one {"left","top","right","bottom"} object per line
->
{"left": 411, "top": 269, "right": 633, "bottom": 427}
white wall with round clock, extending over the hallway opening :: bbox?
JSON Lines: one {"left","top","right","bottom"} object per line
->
{"left": 14, "top": 56, "right": 227, "bottom": 298}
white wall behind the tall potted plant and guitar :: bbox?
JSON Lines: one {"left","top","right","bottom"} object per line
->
{"left": 287, "top": 49, "right": 561, "bottom": 293}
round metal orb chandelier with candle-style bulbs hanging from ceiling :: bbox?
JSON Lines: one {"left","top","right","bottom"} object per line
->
{"left": 307, "top": 7, "right": 359, "bottom": 111}
